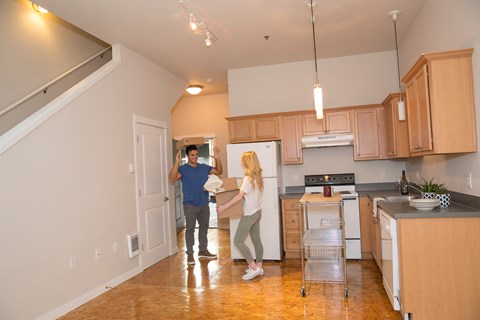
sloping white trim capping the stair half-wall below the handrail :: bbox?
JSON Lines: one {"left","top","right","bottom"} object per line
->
{"left": 0, "top": 45, "right": 122, "bottom": 155}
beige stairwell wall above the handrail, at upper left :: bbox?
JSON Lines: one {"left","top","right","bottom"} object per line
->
{"left": 0, "top": 0, "right": 108, "bottom": 110}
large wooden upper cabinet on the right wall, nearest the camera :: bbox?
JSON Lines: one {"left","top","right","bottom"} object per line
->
{"left": 402, "top": 49, "right": 477, "bottom": 155}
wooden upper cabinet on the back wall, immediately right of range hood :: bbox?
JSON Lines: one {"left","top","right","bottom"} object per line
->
{"left": 352, "top": 106, "right": 386, "bottom": 160}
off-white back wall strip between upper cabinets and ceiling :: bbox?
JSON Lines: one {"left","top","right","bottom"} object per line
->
{"left": 228, "top": 51, "right": 398, "bottom": 116}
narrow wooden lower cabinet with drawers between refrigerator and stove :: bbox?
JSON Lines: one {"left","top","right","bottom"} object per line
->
{"left": 282, "top": 198, "right": 301, "bottom": 259}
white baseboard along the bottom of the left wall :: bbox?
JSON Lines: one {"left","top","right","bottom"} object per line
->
{"left": 36, "top": 266, "right": 142, "bottom": 320}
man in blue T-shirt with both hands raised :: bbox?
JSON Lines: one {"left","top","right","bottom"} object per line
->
{"left": 169, "top": 145, "right": 222, "bottom": 264}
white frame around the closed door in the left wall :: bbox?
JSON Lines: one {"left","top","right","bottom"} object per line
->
{"left": 133, "top": 114, "right": 178, "bottom": 270}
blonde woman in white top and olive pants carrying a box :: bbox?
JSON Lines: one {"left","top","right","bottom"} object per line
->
{"left": 217, "top": 151, "right": 263, "bottom": 280}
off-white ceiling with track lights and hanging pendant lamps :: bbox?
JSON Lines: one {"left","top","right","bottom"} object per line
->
{"left": 38, "top": 0, "right": 425, "bottom": 95}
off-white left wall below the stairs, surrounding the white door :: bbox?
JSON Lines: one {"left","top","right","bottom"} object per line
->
{"left": 0, "top": 47, "right": 187, "bottom": 320}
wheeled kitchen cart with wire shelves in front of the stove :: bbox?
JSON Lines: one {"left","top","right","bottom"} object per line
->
{"left": 299, "top": 193, "right": 348, "bottom": 298}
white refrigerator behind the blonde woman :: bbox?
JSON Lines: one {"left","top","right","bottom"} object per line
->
{"left": 227, "top": 141, "right": 283, "bottom": 261}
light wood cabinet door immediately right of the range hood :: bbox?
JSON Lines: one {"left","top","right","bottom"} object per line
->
{"left": 353, "top": 108, "right": 381, "bottom": 160}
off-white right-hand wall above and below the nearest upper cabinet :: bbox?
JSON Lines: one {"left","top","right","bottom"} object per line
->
{"left": 399, "top": 0, "right": 480, "bottom": 196}
